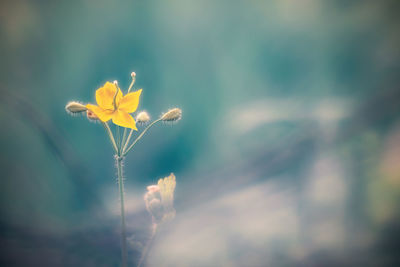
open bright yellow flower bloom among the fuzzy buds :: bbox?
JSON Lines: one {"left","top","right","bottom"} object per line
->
{"left": 86, "top": 82, "right": 142, "bottom": 130}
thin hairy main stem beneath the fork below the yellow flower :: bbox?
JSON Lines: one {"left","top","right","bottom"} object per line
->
{"left": 115, "top": 156, "right": 127, "bottom": 267}
